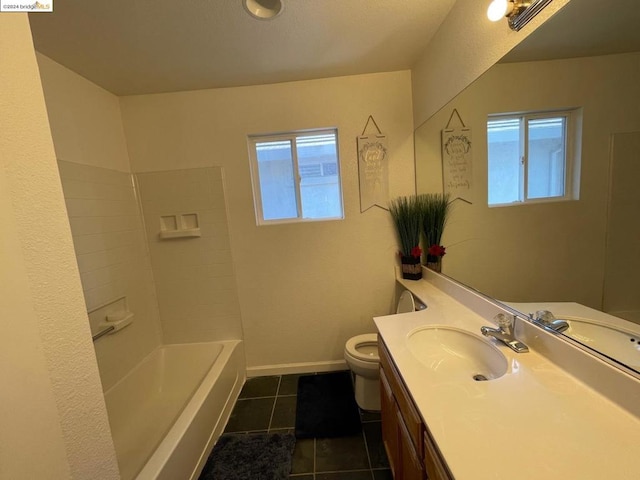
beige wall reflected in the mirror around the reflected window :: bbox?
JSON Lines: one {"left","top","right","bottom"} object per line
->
{"left": 416, "top": 54, "right": 640, "bottom": 308}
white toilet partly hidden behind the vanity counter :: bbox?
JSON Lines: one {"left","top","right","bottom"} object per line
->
{"left": 344, "top": 290, "right": 426, "bottom": 412}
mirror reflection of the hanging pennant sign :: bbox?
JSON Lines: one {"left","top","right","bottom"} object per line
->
{"left": 442, "top": 108, "right": 473, "bottom": 203}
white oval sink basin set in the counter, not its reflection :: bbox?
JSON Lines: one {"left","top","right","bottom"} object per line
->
{"left": 407, "top": 326, "right": 508, "bottom": 380}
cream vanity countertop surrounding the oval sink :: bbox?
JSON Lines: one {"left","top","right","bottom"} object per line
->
{"left": 374, "top": 280, "right": 640, "bottom": 480}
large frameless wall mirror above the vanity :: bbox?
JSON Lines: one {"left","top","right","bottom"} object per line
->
{"left": 415, "top": 0, "right": 640, "bottom": 373}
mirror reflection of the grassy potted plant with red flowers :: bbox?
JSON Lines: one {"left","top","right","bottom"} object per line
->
{"left": 418, "top": 193, "right": 451, "bottom": 272}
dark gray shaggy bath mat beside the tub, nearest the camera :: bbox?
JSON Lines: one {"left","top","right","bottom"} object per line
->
{"left": 199, "top": 433, "right": 296, "bottom": 480}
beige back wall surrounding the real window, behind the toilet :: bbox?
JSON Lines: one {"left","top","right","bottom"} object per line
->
{"left": 121, "top": 71, "right": 414, "bottom": 373}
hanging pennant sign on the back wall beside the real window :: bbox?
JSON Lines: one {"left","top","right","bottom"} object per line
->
{"left": 358, "top": 115, "right": 389, "bottom": 213}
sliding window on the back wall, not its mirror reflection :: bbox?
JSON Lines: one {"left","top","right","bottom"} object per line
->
{"left": 249, "top": 129, "right": 343, "bottom": 225}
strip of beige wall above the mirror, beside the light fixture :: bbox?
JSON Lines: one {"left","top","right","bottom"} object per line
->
{"left": 411, "top": 0, "right": 571, "bottom": 125}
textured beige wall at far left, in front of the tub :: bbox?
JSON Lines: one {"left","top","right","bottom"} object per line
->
{"left": 0, "top": 14, "right": 118, "bottom": 479}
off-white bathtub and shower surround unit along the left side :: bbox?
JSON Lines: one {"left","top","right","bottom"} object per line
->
{"left": 58, "top": 161, "right": 246, "bottom": 479}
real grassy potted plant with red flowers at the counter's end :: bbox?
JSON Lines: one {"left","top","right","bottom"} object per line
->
{"left": 389, "top": 195, "right": 422, "bottom": 280}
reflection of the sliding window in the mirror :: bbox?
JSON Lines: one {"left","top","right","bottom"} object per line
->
{"left": 487, "top": 110, "right": 578, "bottom": 206}
